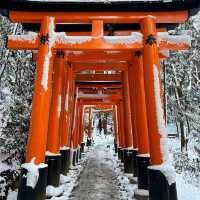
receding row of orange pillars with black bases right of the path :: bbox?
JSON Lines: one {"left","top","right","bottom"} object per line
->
{"left": 111, "top": 18, "right": 177, "bottom": 200}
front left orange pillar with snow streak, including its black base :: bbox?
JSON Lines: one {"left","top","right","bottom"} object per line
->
{"left": 18, "top": 16, "right": 54, "bottom": 200}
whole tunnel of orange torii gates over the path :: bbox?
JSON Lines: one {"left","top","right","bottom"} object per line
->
{"left": 1, "top": 1, "right": 200, "bottom": 200}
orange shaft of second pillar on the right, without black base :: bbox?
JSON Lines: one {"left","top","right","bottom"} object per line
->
{"left": 132, "top": 55, "right": 149, "bottom": 154}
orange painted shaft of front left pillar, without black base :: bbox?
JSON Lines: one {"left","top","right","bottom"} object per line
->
{"left": 26, "top": 17, "right": 53, "bottom": 164}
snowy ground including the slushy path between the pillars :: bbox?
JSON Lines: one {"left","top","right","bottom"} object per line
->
{"left": 7, "top": 135, "right": 200, "bottom": 200}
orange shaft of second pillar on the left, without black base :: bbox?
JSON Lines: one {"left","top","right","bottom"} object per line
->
{"left": 47, "top": 52, "right": 64, "bottom": 154}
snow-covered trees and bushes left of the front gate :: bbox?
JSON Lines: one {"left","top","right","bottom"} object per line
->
{"left": 0, "top": 17, "right": 35, "bottom": 199}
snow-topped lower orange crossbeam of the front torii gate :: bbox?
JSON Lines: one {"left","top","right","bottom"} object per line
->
{"left": 8, "top": 32, "right": 191, "bottom": 51}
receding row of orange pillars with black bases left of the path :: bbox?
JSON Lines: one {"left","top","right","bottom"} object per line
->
{"left": 18, "top": 50, "right": 87, "bottom": 200}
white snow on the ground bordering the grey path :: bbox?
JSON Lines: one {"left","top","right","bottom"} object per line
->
{"left": 5, "top": 128, "right": 200, "bottom": 200}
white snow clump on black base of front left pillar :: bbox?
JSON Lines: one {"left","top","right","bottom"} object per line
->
{"left": 22, "top": 157, "right": 47, "bottom": 189}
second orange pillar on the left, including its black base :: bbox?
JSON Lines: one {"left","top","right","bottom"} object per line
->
{"left": 46, "top": 52, "right": 64, "bottom": 187}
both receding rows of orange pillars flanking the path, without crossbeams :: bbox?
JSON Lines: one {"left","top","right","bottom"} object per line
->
{"left": 15, "top": 17, "right": 177, "bottom": 200}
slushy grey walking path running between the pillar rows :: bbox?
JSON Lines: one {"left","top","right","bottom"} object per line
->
{"left": 71, "top": 144, "right": 120, "bottom": 200}
